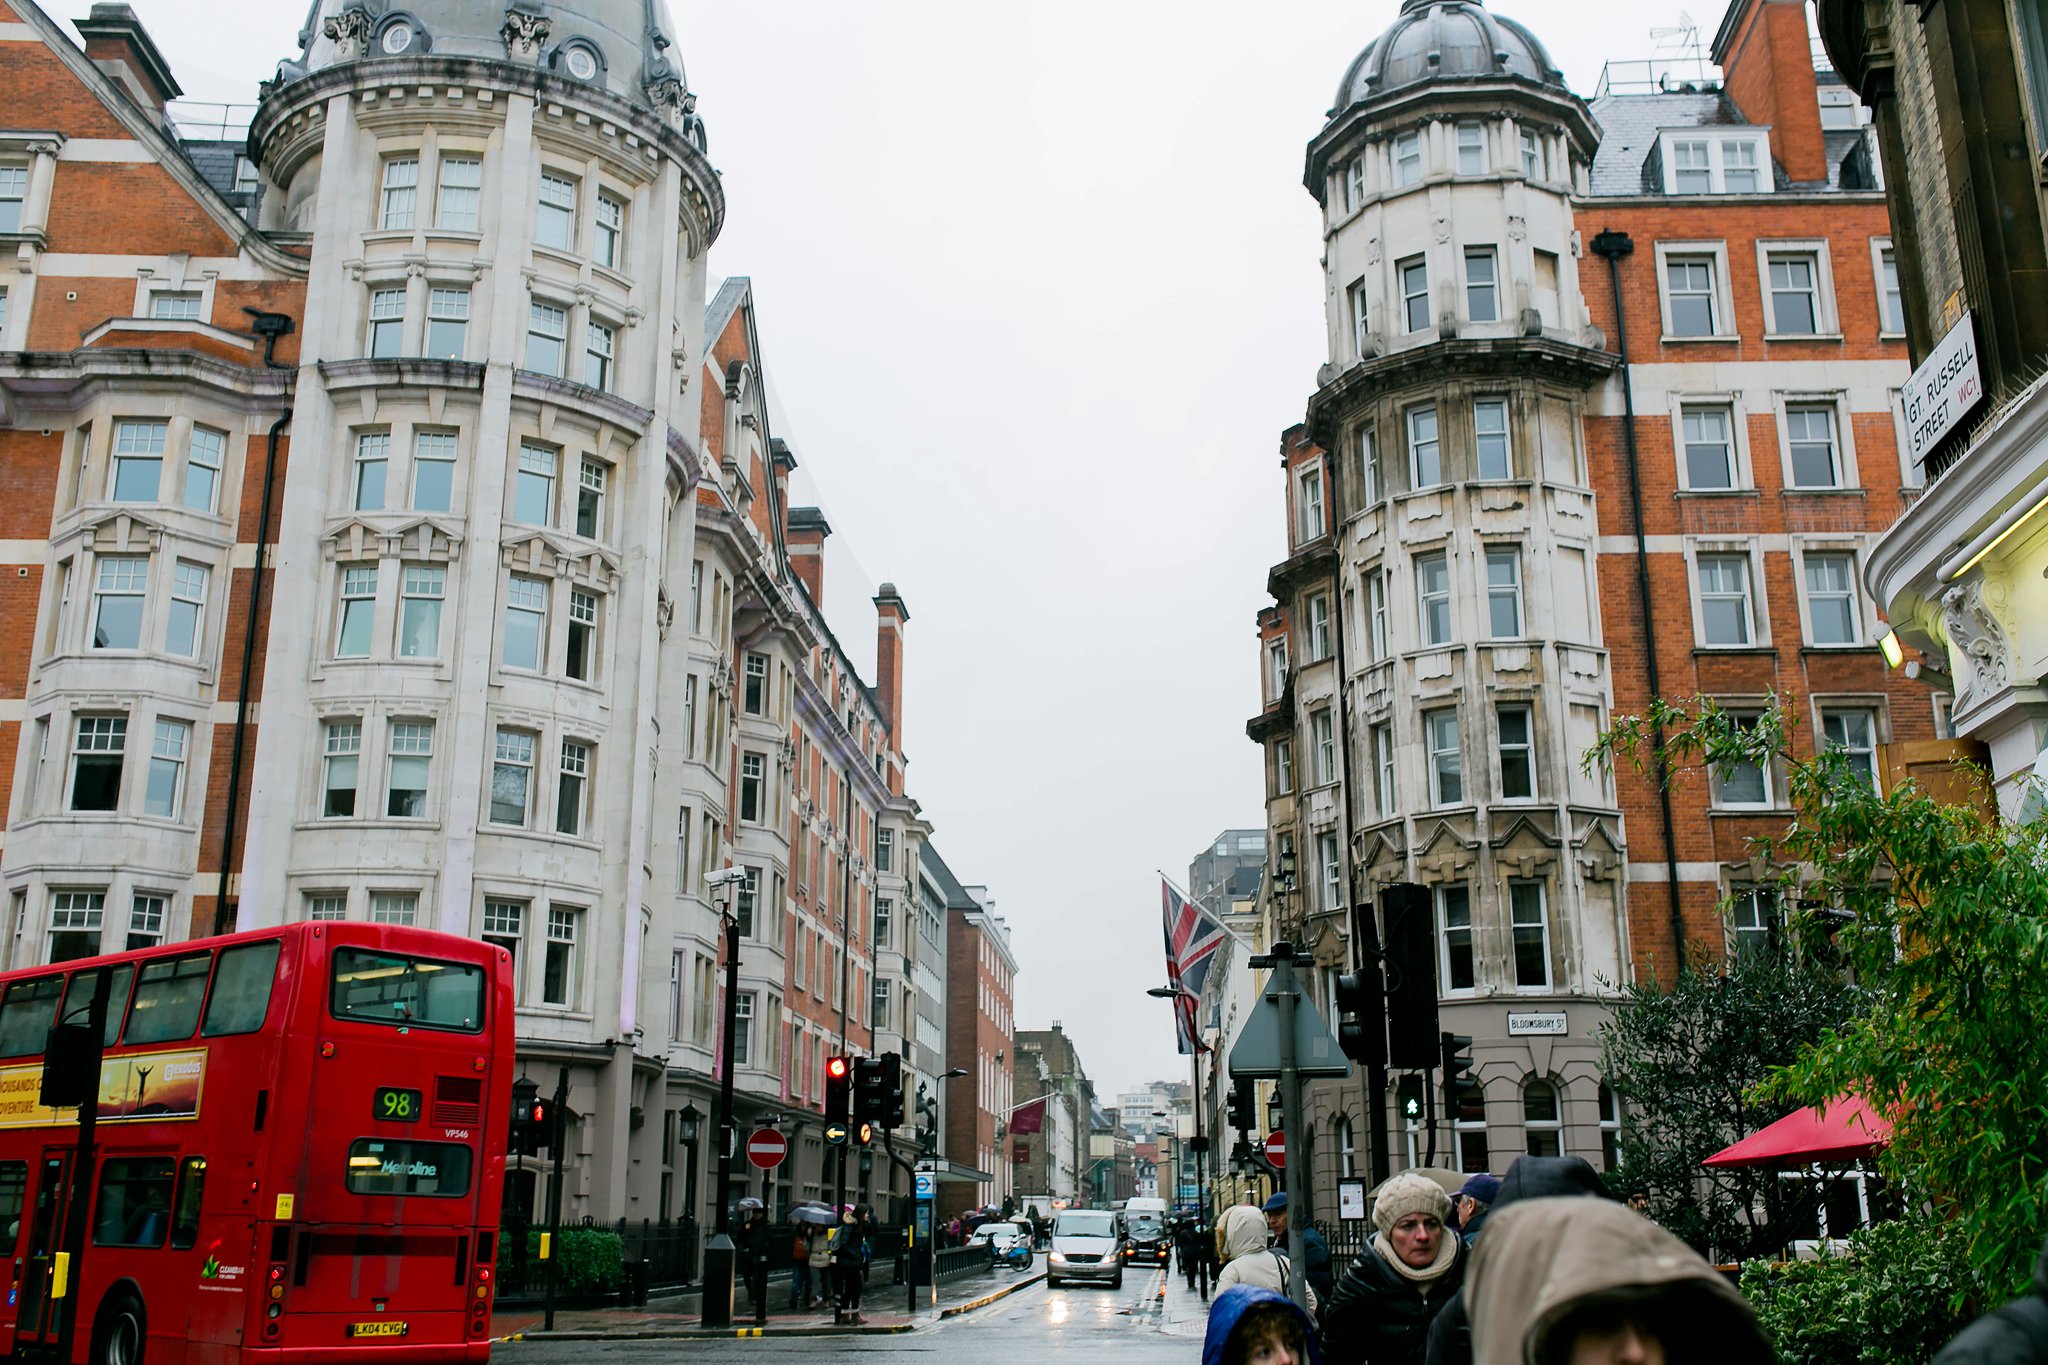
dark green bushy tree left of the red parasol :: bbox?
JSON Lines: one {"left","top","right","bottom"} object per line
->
{"left": 1599, "top": 952, "right": 1858, "bottom": 1261}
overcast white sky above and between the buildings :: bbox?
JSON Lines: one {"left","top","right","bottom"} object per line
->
{"left": 116, "top": 0, "right": 1724, "bottom": 1095}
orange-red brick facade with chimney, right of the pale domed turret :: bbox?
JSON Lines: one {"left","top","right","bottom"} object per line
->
{"left": 1577, "top": 0, "right": 1946, "bottom": 976}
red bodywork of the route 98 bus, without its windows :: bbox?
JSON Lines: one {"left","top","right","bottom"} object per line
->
{"left": 0, "top": 921, "right": 512, "bottom": 1365}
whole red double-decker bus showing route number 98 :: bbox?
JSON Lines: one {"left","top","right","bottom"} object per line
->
{"left": 0, "top": 923, "right": 512, "bottom": 1365}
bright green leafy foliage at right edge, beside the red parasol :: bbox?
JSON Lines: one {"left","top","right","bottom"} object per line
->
{"left": 1591, "top": 698, "right": 2048, "bottom": 1297}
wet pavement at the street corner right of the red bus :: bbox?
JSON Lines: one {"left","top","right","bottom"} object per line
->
{"left": 492, "top": 1269, "right": 1044, "bottom": 1340}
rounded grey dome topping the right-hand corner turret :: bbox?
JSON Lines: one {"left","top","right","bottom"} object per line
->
{"left": 1331, "top": 0, "right": 1565, "bottom": 115}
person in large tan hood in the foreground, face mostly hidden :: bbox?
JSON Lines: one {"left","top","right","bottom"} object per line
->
{"left": 1464, "top": 1199, "right": 1778, "bottom": 1365}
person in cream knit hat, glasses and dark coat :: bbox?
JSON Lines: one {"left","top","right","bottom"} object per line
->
{"left": 1323, "top": 1173, "right": 1464, "bottom": 1365}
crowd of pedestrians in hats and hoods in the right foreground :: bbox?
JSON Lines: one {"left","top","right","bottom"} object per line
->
{"left": 1202, "top": 1156, "right": 2048, "bottom": 1365}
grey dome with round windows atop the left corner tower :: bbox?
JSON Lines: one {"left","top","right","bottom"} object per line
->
{"left": 297, "top": 0, "right": 682, "bottom": 104}
